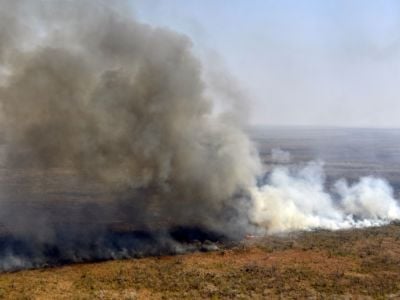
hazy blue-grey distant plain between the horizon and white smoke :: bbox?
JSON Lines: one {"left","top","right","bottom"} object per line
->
{"left": 249, "top": 127, "right": 400, "bottom": 192}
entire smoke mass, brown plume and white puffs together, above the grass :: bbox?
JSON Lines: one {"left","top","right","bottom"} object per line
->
{"left": 0, "top": 0, "right": 400, "bottom": 270}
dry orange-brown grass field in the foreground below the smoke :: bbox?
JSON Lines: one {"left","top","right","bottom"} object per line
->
{"left": 0, "top": 224, "right": 400, "bottom": 299}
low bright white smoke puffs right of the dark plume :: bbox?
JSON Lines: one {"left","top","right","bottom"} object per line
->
{"left": 251, "top": 162, "right": 400, "bottom": 233}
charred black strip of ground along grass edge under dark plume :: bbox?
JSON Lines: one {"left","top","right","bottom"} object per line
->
{"left": 0, "top": 224, "right": 228, "bottom": 271}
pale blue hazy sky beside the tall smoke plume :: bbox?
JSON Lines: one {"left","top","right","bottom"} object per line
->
{"left": 132, "top": 0, "right": 400, "bottom": 127}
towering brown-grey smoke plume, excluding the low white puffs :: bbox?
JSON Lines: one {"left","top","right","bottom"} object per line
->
{"left": 0, "top": 1, "right": 257, "bottom": 222}
